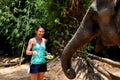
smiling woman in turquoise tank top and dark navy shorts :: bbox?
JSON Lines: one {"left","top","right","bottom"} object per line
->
{"left": 26, "top": 27, "right": 47, "bottom": 80}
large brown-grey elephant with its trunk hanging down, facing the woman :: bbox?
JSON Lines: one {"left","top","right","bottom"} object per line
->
{"left": 61, "top": 0, "right": 120, "bottom": 79}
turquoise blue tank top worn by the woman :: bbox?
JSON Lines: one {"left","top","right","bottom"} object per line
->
{"left": 31, "top": 38, "right": 46, "bottom": 64}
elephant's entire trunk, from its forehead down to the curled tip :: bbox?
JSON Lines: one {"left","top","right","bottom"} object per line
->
{"left": 61, "top": 3, "right": 98, "bottom": 79}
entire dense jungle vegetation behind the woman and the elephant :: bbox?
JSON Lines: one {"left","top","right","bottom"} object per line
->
{"left": 0, "top": 0, "right": 116, "bottom": 56}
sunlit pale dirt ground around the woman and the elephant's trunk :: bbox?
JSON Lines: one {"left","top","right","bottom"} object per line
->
{"left": 0, "top": 58, "right": 120, "bottom": 80}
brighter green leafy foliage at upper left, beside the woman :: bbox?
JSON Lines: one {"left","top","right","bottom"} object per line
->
{"left": 0, "top": 0, "right": 46, "bottom": 54}
